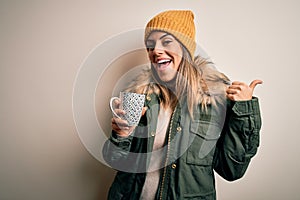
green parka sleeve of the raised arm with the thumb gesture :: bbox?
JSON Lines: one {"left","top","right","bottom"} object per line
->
{"left": 214, "top": 97, "right": 262, "bottom": 181}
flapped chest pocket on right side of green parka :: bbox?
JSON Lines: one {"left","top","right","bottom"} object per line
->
{"left": 186, "top": 120, "right": 222, "bottom": 166}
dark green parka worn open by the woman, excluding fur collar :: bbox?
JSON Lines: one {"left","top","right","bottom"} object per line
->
{"left": 102, "top": 61, "right": 261, "bottom": 200}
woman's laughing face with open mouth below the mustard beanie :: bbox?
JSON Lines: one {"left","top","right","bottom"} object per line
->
{"left": 146, "top": 31, "right": 182, "bottom": 82}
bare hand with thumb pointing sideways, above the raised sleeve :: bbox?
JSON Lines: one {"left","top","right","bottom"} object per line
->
{"left": 226, "top": 80, "right": 263, "bottom": 101}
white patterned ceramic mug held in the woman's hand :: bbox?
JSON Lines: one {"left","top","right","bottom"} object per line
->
{"left": 109, "top": 92, "right": 145, "bottom": 126}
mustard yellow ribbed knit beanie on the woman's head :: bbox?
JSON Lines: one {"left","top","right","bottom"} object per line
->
{"left": 144, "top": 10, "right": 196, "bottom": 59}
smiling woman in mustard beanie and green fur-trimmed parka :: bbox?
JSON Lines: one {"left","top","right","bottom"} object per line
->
{"left": 103, "top": 10, "right": 262, "bottom": 200}
